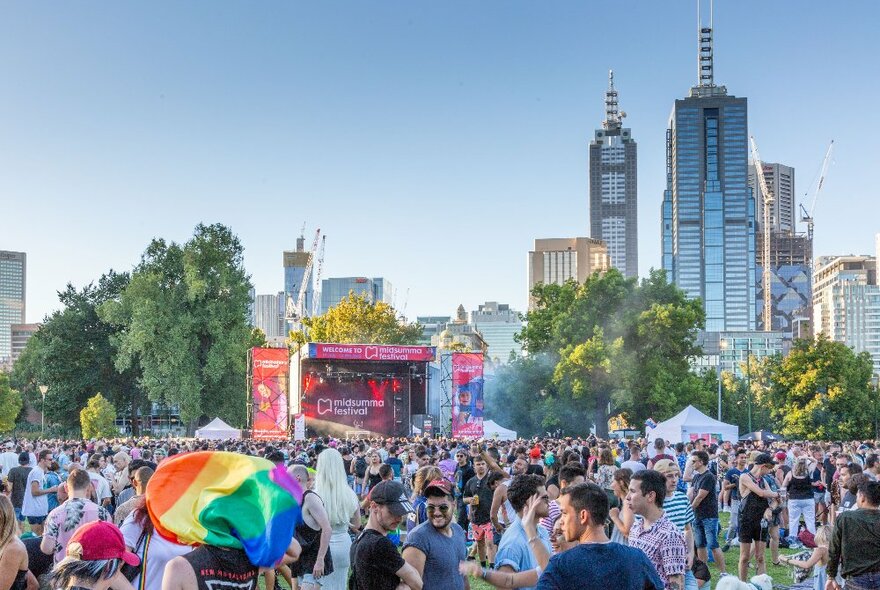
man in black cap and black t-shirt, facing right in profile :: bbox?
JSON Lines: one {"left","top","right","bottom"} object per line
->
{"left": 349, "top": 480, "right": 422, "bottom": 590}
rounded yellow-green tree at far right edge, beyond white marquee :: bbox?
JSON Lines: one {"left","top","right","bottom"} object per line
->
{"left": 766, "top": 334, "right": 874, "bottom": 440}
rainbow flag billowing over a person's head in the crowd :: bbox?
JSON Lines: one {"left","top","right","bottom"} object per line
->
{"left": 146, "top": 451, "right": 303, "bottom": 567}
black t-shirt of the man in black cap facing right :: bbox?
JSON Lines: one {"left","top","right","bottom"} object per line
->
{"left": 348, "top": 529, "right": 405, "bottom": 590}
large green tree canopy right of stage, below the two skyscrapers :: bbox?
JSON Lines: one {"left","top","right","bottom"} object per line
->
{"left": 498, "top": 269, "right": 713, "bottom": 436}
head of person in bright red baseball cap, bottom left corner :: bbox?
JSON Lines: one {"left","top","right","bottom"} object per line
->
{"left": 52, "top": 521, "right": 140, "bottom": 590}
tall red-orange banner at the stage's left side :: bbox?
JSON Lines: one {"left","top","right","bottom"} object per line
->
{"left": 251, "top": 348, "right": 290, "bottom": 440}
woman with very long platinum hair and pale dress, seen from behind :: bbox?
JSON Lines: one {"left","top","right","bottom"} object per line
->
{"left": 315, "top": 448, "right": 361, "bottom": 590}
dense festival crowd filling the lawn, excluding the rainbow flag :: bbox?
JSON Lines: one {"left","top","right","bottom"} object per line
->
{"left": 0, "top": 437, "right": 880, "bottom": 590}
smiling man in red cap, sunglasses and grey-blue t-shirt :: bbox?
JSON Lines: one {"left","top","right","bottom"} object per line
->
{"left": 403, "top": 479, "right": 467, "bottom": 590}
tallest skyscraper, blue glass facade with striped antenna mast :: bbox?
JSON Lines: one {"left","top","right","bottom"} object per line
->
{"left": 662, "top": 10, "right": 755, "bottom": 332}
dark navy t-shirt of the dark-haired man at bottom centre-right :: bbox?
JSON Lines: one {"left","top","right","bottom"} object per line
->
{"left": 537, "top": 543, "right": 663, "bottom": 590}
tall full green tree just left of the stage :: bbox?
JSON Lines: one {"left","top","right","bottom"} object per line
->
{"left": 99, "top": 224, "right": 258, "bottom": 432}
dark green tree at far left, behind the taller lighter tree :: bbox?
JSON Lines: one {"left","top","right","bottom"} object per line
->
{"left": 12, "top": 270, "right": 146, "bottom": 434}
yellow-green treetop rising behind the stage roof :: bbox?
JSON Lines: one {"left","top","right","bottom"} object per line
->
{"left": 290, "top": 292, "right": 422, "bottom": 345}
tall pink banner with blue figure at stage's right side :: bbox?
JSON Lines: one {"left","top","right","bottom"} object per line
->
{"left": 452, "top": 352, "right": 483, "bottom": 438}
